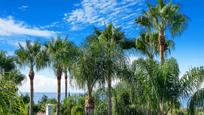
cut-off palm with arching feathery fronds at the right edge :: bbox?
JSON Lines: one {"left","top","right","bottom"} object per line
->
{"left": 181, "top": 66, "right": 204, "bottom": 115}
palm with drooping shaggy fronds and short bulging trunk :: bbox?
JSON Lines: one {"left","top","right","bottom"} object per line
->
{"left": 74, "top": 35, "right": 103, "bottom": 115}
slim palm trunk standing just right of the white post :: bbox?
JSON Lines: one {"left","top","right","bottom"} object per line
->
{"left": 57, "top": 70, "right": 62, "bottom": 115}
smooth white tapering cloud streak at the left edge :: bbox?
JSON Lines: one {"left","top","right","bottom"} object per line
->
{"left": 0, "top": 17, "right": 55, "bottom": 37}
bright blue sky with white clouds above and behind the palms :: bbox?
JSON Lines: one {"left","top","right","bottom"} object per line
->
{"left": 0, "top": 0, "right": 204, "bottom": 92}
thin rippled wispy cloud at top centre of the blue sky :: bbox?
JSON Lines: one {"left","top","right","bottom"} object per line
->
{"left": 65, "top": 0, "right": 144, "bottom": 30}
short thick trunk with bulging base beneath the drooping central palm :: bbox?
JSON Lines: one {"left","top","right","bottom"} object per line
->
{"left": 85, "top": 84, "right": 94, "bottom": 115}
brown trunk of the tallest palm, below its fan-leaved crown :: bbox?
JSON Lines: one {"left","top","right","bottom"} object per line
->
{"left": 159, "top": 30, "right": 165, "bottom": 63}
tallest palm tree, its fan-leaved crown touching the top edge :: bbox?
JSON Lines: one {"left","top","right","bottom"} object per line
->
{"left": 136, "top": 0, "right": 188, "bottom": 63}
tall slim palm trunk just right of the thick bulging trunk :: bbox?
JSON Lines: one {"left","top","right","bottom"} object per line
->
{"left": 108, "top": 75, "right": 112, "bottom": 115}
